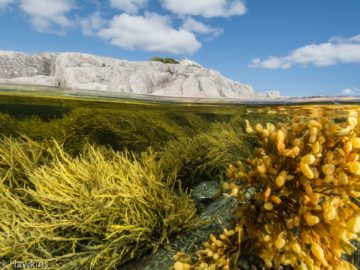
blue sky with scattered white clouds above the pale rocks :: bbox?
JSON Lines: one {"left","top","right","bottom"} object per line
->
{"left": 0, "top": 0, "right": 360, "bottom": 96}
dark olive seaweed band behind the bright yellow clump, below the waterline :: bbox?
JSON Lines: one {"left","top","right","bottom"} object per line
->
{"left": 0, "top": 107, "right": 211, "bottom": 154}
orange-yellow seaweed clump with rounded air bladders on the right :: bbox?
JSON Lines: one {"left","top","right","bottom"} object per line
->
{"left": 173, "top": 113, "right": 360, "bottom": 270}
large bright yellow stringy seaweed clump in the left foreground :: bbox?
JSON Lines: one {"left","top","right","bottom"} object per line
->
{"left": 0, "top": 137, "right": 195, "bottom": 269}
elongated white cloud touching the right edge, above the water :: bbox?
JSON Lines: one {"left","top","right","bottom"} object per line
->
{"left": 249, "top": 35, "right": 360, "bottom": 69}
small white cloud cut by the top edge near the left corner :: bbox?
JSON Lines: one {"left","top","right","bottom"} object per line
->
{"left": 20, "top": 0, "right": 74, "bottom": 33}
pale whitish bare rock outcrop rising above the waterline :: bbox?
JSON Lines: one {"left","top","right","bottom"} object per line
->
{"left": 0, "top": 51, "right": 273, "bottom": 98}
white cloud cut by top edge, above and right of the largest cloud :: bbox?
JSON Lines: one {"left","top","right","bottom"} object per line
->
{"left": 161, "top": 0, "right": 246, "bottom": 18}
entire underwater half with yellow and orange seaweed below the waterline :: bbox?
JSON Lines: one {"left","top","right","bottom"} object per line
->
{"left": 0, "top": 90, "right": 360, "bottom": 270}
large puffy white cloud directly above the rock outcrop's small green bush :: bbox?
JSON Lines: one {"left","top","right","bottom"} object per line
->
{"left": 98, "top": 13, "right": 201, "bottom": 54}
